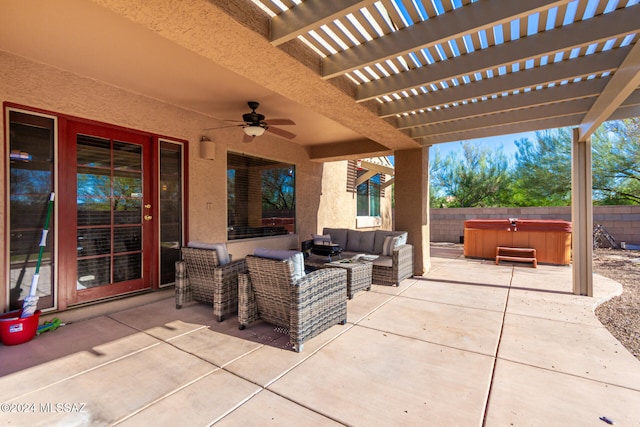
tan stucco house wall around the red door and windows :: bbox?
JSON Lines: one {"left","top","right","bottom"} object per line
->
{"left": 0, "top": 51, "right": 368, "bottom": 306}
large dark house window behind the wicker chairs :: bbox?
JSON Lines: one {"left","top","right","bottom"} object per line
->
{"left": 227, "top": 153, "right": 296, "bottom": 240}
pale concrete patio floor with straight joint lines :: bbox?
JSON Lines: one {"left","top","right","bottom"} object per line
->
{"left": 0, "top": 246, "right": 640, "bottom": 426}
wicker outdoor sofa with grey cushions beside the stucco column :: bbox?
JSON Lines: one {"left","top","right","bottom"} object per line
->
{"left": 313, "top": 227, "right": 413, "bottom": 286}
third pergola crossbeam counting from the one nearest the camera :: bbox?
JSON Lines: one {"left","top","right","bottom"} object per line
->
{"left": 356, "top": 5, "right": 640, "bottom": 102}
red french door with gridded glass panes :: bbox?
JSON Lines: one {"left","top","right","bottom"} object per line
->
{"left": 59, "top": 121, "right": 154, "bottom": 305}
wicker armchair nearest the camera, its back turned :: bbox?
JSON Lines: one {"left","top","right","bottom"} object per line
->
{"left": 238, "top": 255, "right": 347, "bottom": 352}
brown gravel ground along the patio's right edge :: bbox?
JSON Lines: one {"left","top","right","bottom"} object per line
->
{"left": 593, "top": 249, "right": 640, "bottom": 360}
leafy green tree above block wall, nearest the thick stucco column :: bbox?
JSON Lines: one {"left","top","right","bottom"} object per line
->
{"left": 430, "top": 141, "right": 509, "bottom": 207}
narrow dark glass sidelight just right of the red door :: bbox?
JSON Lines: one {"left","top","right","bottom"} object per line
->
{"left": 159, "top": 142, "right": 182, "bottom": 285}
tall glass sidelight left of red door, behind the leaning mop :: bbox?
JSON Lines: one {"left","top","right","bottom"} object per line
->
{"left": 8, "top": 111, "right": 55, "bottom": 310}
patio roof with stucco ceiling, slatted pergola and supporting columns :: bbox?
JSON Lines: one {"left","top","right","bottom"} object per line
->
{"left": 0, "top": 0, "right": 640, "bottom": 295}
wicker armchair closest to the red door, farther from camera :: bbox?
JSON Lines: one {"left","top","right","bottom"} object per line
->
{"left": 176, "top": 247, "right": 247, "bottom": 322}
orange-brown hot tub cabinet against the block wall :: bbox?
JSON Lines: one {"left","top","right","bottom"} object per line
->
{"left": 464, "top": 219, "right": 571, "bottom": 265}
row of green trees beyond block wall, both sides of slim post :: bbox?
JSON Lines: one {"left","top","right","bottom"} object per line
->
{"left": 430, "top": 117, "right": 640, "bottom": 207}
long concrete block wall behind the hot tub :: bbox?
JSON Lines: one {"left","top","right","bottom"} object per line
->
{"left": 430, "top": 206, "right": 640, "bottom": 243}
